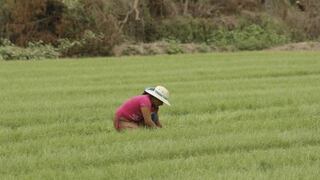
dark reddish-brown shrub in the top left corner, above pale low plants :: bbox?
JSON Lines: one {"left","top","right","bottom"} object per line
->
{"left": 0, "top": 0, "right": 66, "bottom": 46}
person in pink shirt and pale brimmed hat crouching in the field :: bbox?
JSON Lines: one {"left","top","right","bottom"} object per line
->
{"left": 113, "top": 86, "right": 170, "bottom": 131}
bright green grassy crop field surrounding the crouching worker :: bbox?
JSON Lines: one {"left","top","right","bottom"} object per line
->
{"left": 0, "top": 52, "right": 320, "bottom": 180}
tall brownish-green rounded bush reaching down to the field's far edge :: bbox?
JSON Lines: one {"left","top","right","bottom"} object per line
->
{"left": 59, "top": 0, "right": 122, "bottom": 56}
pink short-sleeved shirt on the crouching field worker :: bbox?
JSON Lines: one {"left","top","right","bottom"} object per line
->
{"left": 116, "top": 95, "right": 153, "bottom": 121}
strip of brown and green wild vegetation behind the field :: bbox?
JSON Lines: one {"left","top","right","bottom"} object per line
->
{"left": 0, "top": 0, "right": 320, "bottom": 59}
